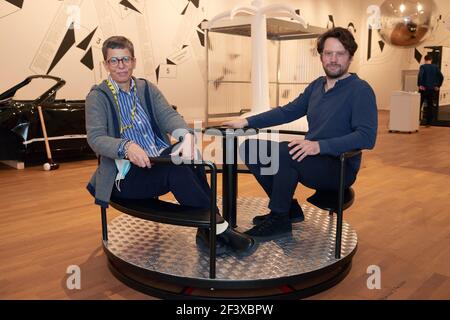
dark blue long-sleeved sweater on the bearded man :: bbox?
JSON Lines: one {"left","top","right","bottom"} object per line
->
{"left": 247, "top": 74, "right": 378, "bottom": 166}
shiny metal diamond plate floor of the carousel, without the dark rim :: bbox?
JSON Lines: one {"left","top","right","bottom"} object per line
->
{"left": 106, "top": 198, "right": 358, "bottom": 280}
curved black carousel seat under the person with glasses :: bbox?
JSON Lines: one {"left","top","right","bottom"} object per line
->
{"left": 110, "top": 198, "right": 224, "bottom": 228}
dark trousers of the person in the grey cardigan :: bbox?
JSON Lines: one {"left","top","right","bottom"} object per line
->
{"left": 112, "top": 146, "right": 211, "bottom": 208}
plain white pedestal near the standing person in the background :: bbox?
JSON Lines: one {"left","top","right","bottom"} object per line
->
{"left": 389, "top": 91, "right": 420, "bottom": 132}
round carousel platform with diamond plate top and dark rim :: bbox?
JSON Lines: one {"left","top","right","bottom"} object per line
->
{"left": 103, "top": 198, "right": 358, "bottom": 299}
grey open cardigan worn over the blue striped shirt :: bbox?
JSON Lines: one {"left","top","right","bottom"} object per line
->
{"left": 85, "top": 79, "right": 192, "bottom": 208}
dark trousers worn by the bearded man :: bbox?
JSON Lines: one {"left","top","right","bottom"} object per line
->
{"left": 239, "top": 139, "right": 358, "bottom": 212}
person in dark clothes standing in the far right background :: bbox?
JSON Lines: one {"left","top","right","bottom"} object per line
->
{"left": 417, "top": 54, "right": 444, "bottom": 127}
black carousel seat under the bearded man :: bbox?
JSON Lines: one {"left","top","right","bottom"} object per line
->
{"left": 306, "top": 187, "right": 355, "bottom": 214}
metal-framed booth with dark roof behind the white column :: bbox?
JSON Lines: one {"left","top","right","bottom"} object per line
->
{"left": 202, "top": 17, "right": 326, "bottom": 123}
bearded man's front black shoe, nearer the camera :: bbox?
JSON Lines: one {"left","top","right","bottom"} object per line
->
{"left": 244, "top": 212, "right": 292, "bottom": 242}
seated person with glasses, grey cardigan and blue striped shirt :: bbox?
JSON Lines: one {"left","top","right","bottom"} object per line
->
{"left": 86, "top": 36, "right": 254, "bottom": 254}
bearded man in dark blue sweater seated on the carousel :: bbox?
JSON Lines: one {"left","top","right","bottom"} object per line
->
{"left": 224, "top": 27, "right": 378, "bottom": 241}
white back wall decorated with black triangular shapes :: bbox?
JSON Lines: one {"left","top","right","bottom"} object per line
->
{"left": 0, "top": 0, "right": 450, "bottom": 120}
